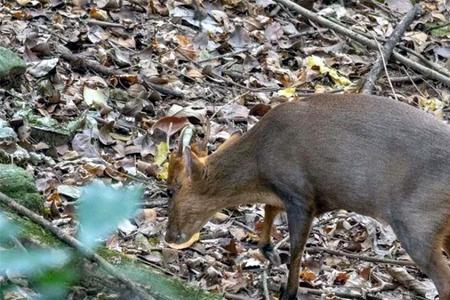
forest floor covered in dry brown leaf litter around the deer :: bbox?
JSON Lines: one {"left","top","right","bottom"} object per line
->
{"left": 0, "top": 0, "right": 450, "bottom": 299}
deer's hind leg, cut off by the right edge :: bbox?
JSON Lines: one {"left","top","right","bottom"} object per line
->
{"left": 392, "top": 218, "right": 450, "bottom": 300}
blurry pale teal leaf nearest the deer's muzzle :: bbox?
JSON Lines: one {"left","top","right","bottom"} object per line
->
{"left": 77, "top": 183, "right": 142, "bottom": 248}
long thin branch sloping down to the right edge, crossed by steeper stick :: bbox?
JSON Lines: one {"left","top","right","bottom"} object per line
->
{"left": 276, "top": 0, "right": 450, "bottom": 87}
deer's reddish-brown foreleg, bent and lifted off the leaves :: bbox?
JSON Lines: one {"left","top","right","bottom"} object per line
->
{"left": 258, "top": 205, "right": 282, "bottom": 266}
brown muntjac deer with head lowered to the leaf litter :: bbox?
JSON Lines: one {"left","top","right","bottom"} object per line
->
{"left": 166, "top": 94, "right": 450, "bottom": 300}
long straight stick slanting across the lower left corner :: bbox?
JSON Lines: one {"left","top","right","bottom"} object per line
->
{"left": 0, "top": 193, "right": 155, "bottom": 300}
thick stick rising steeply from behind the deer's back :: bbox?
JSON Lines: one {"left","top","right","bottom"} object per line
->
{"left": 361, "top": 4, "right": 419, "bottom": 95}
